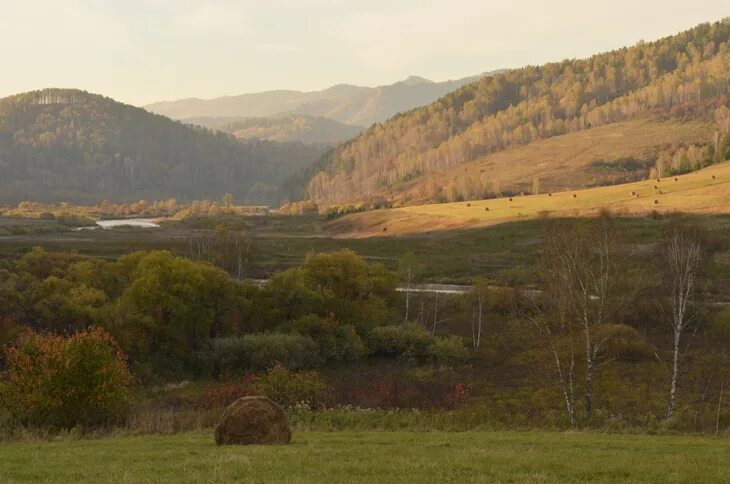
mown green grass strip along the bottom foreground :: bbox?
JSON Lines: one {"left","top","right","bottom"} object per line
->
{"left": 0, "top": 432, "right": 730, "bottom": 483}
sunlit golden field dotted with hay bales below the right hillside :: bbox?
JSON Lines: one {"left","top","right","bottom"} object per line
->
{"left": 330, "top": 162, "right": 730, "bottom": 237}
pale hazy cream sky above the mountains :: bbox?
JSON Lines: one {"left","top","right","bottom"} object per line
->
{"left": 0, "top": 0, "right": 730, "bottom": 104}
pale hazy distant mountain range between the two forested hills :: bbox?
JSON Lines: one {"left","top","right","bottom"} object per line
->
{"left": 144, "top": 71, "right": 500, "bottom": 127}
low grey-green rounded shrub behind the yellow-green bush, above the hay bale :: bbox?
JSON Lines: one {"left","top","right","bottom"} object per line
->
{"left": 205, "top": 333, "right": 320, "bottom": 373}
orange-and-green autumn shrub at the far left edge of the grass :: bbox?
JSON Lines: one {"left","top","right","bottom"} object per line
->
{"left": 0, "top": 328, "right": 132, "bottom": 428}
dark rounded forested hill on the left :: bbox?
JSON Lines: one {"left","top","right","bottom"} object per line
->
{"left": 0, "top": 89, "right": 326, "bottom": 203}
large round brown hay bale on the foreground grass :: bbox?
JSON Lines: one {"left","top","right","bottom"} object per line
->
{"left": 215, "top": 397, "right": 291, "bottom": 445}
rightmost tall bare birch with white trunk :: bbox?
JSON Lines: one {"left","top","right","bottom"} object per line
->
{"left": 662, "top": 222, "right": 703, "bottom": 417}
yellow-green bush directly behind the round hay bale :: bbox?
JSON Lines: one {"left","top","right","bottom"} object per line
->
{"left": 252, "top": 365, "right": 328, "bottom": 408}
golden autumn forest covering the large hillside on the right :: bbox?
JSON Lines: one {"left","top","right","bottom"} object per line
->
{"left": 308, "top": 19, "right": 730, "bottom": 205}
